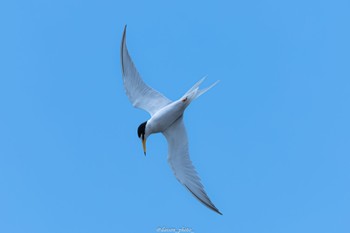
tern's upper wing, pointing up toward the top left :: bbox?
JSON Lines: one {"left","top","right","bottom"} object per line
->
{"left": 120, "top": 26, "right": 171, "bottom": 115}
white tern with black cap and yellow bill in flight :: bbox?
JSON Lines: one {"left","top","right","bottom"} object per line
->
{"left": 120, "top": 26, "right": 222, "bottom": 215}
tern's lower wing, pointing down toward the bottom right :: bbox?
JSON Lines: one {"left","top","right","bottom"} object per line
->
{"left": 163, "top": 116, "right": 221, "bottom": 214}
